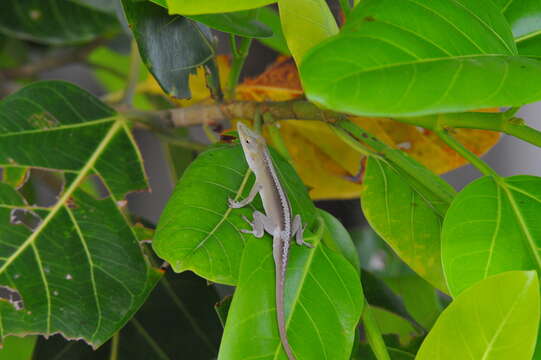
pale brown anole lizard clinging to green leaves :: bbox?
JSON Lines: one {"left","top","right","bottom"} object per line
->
{"left": 229, "top": 122, "right": 312, "bottom": 360}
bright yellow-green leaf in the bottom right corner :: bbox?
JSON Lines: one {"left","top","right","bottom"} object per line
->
{"left": 416, "top": 271, "right": 539, "bottom": 360}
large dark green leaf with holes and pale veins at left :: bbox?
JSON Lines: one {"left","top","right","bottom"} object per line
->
{"left": 0, "top": 81, "right": 159, "bottom": 347}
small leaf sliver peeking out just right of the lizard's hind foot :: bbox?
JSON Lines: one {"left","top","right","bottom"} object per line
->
{"left": 318, "top": 209, "right": 361, "bottom": 272}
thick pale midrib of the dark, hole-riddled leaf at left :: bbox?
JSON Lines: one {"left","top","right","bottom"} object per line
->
{"left": 0, "top": 120, "right": 122, "bottom": 274}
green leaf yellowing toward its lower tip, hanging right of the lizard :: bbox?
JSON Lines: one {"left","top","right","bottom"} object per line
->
{"left": 361, "top": 157, "right": 446, "bottom": 290}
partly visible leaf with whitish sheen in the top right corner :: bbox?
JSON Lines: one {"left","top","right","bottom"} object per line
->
{"left": 493, "top": 0, "right": 541, "bottom": 56}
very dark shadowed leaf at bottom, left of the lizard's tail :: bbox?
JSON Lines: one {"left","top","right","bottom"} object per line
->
{"left": 33, "top": 272, "right": 222, "bottom": 360}
